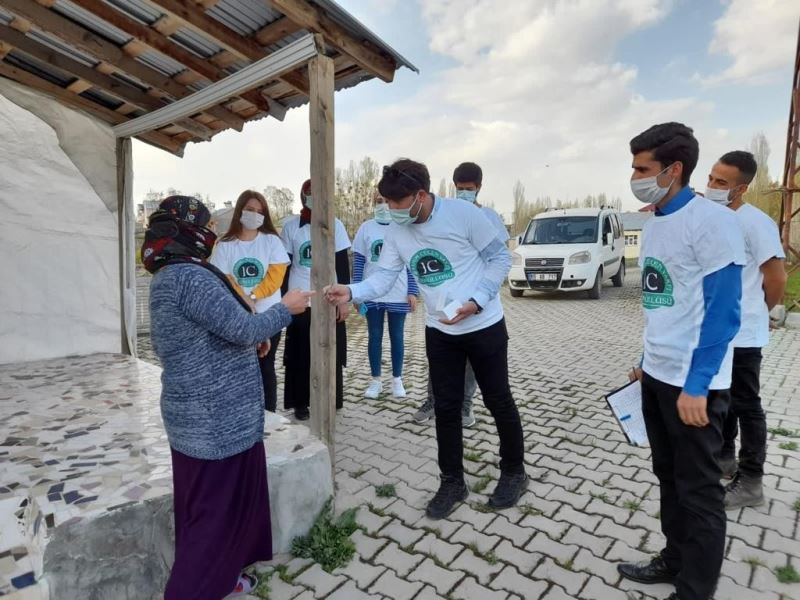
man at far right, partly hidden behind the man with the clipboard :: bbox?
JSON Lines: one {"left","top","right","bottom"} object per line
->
{"left": 706, "top": 150, "right": 786, "bottom": 510}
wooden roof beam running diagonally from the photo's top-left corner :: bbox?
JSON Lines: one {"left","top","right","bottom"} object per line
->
{"left": 2, "top": 0, "right": 244, "bottom": 131}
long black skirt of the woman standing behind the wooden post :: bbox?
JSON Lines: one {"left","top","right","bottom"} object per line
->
{"left": 283, "top": 308, "right": 347, "bottom": 410}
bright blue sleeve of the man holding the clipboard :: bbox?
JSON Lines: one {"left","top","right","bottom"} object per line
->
{"left": 683, "top": 263, "right": 742, "bottom": 396}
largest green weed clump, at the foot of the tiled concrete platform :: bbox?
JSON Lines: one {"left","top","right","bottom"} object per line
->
{"left": 292, "top": 499, "right": 358, "bottom": 573}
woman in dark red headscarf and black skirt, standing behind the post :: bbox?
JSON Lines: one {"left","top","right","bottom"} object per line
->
{"left": 281, "top": 180, "right": 350, "bottom": 421}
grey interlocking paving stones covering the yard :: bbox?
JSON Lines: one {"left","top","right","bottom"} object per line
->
{"left": 136, "top": 270, "right": 800, "bottom": 600}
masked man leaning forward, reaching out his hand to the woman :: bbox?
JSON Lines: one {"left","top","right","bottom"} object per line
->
{"left": 325, "top": 159, "right": 528, "bottom": 519}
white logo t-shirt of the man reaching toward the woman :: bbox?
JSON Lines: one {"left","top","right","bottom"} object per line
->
{"left": 378, "top": 197, "right": 503, "bottom": 335}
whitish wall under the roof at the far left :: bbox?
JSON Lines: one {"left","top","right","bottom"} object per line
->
{"left": 0, "top": 79, "right": 121, "bottom": 363}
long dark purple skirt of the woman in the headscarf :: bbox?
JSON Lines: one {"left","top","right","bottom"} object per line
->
{"left": 164, "top": 442, "right": 272, "bottom": 600}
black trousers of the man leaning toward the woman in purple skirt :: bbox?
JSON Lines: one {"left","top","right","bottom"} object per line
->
{"left": 425, "top": 319, "right": 525, "bottom": 477}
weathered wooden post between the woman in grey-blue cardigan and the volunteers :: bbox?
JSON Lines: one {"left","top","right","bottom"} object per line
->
{"left": 308, "top": 54, "right": 336, "bottom": 471}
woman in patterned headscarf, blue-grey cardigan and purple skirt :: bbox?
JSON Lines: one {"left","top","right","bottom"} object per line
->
{"left": 142, "top": 196, "right": 311, "bottom": 600}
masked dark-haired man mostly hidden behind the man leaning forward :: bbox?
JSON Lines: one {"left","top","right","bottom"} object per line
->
{"left": 414, "top": 162, "right": 509, "bottom": 427}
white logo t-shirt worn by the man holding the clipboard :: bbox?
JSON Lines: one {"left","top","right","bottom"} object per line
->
{"left": 639, "top": 196, "right": 746, "bottom": 390}
